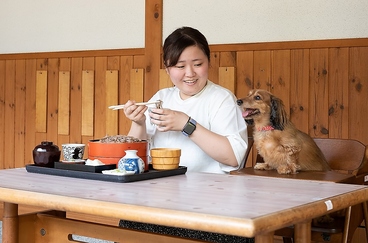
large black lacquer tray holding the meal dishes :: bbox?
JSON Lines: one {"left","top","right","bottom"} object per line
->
{"left": 26, "top": 164, "right": 187, "bottom": 183}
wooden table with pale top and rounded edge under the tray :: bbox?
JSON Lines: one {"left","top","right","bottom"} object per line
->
{"left": 0, "top": 168, "right": 368, "bottom": 243}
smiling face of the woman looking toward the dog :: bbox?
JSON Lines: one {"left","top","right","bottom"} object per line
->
{"left": 166, "top": 46, "right": 209, "bottom": 100}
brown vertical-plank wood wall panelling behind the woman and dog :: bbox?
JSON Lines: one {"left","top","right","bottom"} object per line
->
{"left": 0, "top": 39, "right": 368, "bottom": 168}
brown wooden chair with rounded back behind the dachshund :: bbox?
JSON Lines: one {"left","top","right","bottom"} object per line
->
{"left": 275, "top": 138, "right": 368, "bottom": 243}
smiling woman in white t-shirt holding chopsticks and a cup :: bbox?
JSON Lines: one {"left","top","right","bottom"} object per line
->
{"left": 124, "top": 27, "right": 247, "bottom": 173}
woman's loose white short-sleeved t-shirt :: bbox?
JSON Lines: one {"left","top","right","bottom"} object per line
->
{"left": 146, "top": 81, "right": 248, "bottom": 173}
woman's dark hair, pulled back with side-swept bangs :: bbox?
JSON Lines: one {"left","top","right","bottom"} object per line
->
{"left": 163, "top": 27, "right": 210, "bottom": 67}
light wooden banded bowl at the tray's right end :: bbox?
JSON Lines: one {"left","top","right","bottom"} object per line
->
{"left": 150, "top": 148, "right": 181, "bottom": 170}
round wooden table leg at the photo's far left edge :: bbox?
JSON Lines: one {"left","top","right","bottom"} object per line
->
{"left": 3, "top": 203, "right": 19, "bottom": 243}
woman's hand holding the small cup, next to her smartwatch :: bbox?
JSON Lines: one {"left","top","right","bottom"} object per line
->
{"left": 149, "top": 108, "right": 189, "bottom": 132}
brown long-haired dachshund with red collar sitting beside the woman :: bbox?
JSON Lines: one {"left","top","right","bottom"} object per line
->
{"left": 237, "top": 89, "right": 330, "bottom": 174}
